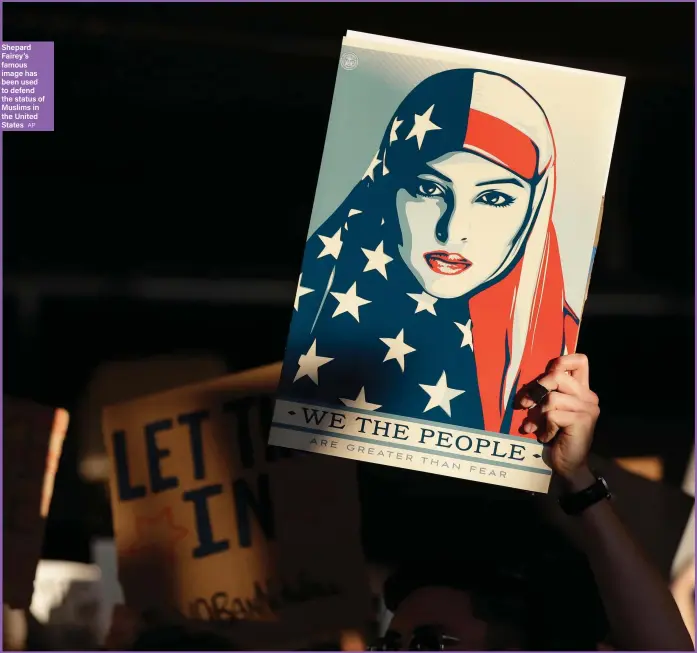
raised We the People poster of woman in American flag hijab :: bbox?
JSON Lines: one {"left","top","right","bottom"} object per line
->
{"left": 270, "top": 32, "right": 624, "bottom": 492}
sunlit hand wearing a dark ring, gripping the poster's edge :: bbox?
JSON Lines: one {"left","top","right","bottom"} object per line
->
{"left": 520, "top": 354, "right": 600, "bottom": 490}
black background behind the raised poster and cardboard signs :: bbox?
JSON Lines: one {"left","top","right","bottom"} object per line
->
{"left": 2, "top": 2, "right": 695, "bottom": 559}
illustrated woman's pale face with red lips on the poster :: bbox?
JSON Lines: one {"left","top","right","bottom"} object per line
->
{"left": 397, "top": 152, "right": 532, "bottom": 299}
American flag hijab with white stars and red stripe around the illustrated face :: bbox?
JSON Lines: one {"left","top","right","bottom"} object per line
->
{"left": 278, "top": 69, "right": 579, "bottom": 435}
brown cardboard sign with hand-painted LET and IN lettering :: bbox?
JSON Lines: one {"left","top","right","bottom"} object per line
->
{"left": 104, "top": 365, "right": 369, "bottom": 647}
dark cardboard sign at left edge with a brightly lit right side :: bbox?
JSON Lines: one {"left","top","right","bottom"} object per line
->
{"left": 3, "top": 397, "right": 69, "bottom": 609}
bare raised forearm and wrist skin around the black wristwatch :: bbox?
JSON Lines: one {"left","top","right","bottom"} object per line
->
{"left": 564, "top": 469, "right": 694, "bottom": 651}
